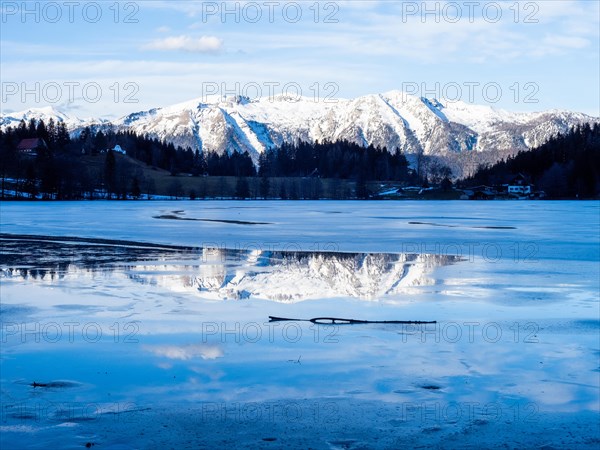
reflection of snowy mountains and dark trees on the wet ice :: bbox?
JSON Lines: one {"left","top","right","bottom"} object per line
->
{"left": 0, "top": 237, "right": 461, "bottom": 302}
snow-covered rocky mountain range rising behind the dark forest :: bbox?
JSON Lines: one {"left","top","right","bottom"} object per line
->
{"left": 0, "top": 91, "right": 600, "bottom": 175}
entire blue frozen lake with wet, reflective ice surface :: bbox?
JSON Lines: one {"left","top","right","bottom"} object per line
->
{"left": 0, "top": 201, "right": 600, "bottom": 449}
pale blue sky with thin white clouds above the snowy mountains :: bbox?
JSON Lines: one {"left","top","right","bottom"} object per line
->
{"left": 0, "top": 0, "right": 600, "bottom": 118}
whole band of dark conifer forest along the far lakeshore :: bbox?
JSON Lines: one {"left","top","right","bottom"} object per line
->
{"left": 0, "top": 119, "right": 600, "bottom": 199}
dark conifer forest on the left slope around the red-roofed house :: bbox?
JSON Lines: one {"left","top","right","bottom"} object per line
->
{"left": 0, "top": 118, "right": 256, "bottom": 200}
